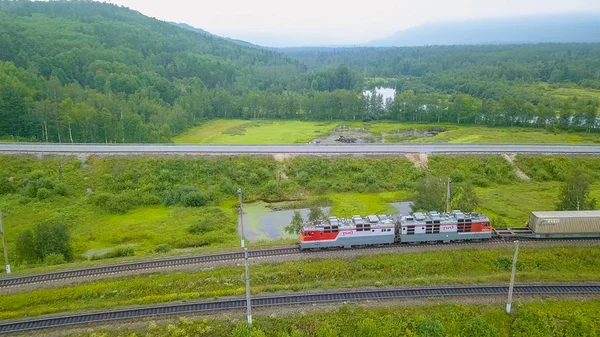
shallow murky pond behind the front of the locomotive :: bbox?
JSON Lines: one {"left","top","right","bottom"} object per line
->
{"left": 238, "top": 202, "right": 411, "bottom": 242}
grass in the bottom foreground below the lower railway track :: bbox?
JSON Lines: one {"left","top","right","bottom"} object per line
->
{"left": 49, "top": 300, "right": 600, "bottom": 337}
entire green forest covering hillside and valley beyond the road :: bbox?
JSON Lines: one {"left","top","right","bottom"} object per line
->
{"left": 0, "top": 0, "right": 600, "bottom": 143}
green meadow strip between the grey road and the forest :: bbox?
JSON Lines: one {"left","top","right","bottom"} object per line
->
{"left": 174, "top": 118, "right": 600, "bottom": 144}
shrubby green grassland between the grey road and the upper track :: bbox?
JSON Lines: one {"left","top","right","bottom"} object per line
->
{"left": 0, "top": 156, "right": 600, "bottom": 274}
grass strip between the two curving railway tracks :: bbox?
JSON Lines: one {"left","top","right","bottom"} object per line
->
{"left": 0, "top": 245, "right": 600, "bottom": 319}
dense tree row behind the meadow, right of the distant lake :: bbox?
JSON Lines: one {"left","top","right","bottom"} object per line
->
{"left": 387, "top": 90, "right": 600, "bottom": 131}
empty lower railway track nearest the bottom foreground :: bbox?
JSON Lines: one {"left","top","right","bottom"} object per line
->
{"left": 0, "top": 283, "right": 600, "bottom": 334}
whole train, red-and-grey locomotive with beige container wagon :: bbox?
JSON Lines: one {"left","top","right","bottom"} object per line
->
{"left": 298, "top": 210, "right": 600, "bottom": 250}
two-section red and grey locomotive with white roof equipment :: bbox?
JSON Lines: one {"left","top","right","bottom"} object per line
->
{"left": 299, "top": 211, "right": 492, "bottom": 249}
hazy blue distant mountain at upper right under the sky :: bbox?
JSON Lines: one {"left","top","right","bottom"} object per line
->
{"left": 368, "top": 13, "right": 600, "bottom": 47}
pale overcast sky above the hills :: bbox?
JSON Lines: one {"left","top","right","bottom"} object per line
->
{"left": 106, "top": 0, "right": 600, "bottom": 47}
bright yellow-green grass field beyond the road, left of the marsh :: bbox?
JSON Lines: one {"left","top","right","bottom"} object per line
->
{"left": 174, "top": 120, "right": 337, "bottom": 144}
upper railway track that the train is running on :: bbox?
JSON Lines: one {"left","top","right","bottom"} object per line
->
{"left": 0, "top": 238, "right": 600, "bottom": 289}
